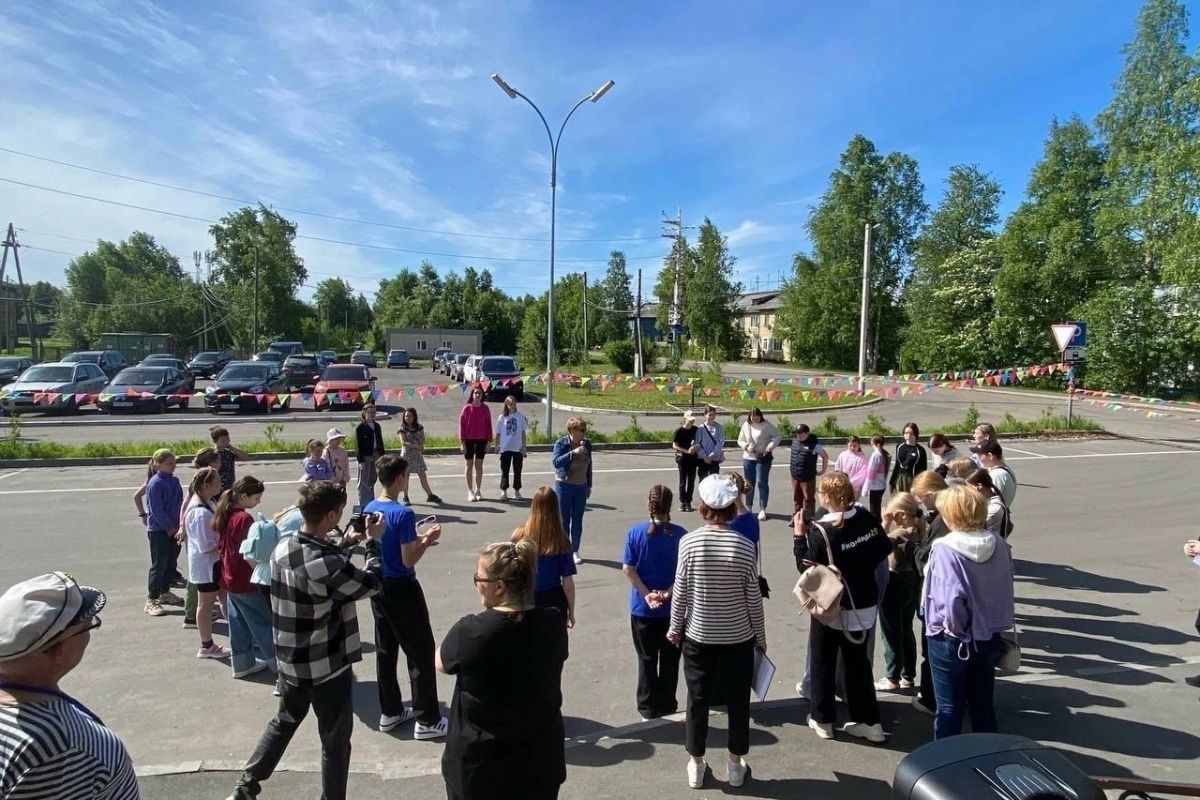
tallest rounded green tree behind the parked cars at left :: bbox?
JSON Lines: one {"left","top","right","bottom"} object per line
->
{"left": 209, "top": 205, "right": 308, "bottom": 349}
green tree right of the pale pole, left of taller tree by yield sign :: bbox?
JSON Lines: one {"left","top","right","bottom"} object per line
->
{"left": 900, "top": 164, "right": 1001, "bottom": 371}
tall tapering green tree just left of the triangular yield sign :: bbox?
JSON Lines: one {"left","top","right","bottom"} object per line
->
{"left": 990, "top": 118, "right": 1104, "bottom": 365}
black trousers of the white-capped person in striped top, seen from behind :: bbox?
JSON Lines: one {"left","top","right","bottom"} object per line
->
{"left": 683, "top": 639, "right": 754, "bottom": 756}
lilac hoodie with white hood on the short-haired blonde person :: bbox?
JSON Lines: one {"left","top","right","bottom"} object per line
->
{"left": 922, "top": 530, "right": 1013, "bottom": 642}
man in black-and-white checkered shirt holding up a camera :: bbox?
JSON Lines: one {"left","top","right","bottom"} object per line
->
{"left": 229, "top": 481, "right": 384, "bottom": 800}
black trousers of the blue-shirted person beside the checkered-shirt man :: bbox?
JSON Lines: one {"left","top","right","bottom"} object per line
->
{"left": 371, "top": 578, "right": 442, "bottom": 724}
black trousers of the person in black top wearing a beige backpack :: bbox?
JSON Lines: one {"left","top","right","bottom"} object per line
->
{"left": 809, "top": 619, "right": 880, "bottom": 724}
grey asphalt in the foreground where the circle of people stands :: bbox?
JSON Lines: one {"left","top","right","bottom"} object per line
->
{"left": 0, "top": 441, "right": 1200, "bottom": 800}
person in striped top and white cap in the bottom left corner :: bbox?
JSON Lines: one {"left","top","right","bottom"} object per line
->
{"left": 0, "top": 572, "right": 139, "bottom": 800}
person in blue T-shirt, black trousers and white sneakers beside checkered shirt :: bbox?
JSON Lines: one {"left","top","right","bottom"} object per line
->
{"left": 364, "top": 455, "right": 449, "bottom": 740}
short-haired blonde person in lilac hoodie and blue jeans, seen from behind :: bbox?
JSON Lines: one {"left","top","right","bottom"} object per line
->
{"left": 922, "top": 486, "right": 1013, "bottom": 739}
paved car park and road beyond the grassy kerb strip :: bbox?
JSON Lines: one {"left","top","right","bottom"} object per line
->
{"left": 9, "top": 357, "right": 1200, "bottom": 444}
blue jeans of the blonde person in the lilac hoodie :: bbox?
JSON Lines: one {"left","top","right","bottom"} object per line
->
{"left": 926, "top": 633, "right": 1001, "bottom": 739}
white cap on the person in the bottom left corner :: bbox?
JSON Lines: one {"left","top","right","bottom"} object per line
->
{"left": 0, "top": 572, "right": 108, "bottom": 661}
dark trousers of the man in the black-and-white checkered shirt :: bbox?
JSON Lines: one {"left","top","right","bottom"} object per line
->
{"left": 238, "top": 669, "right": 354, "bottom": 800}
